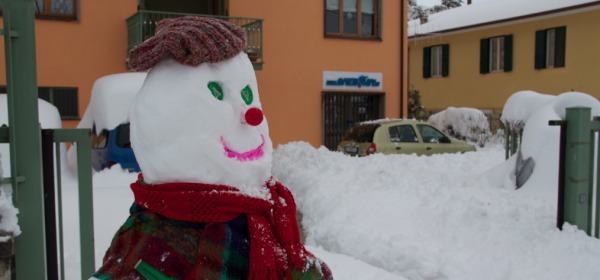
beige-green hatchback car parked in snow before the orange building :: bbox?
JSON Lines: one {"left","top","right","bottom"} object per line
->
{"left": 338, "top": 119, "right": 475, "bottom": 156}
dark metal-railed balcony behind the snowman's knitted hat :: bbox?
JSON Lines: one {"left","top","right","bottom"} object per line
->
{"left": 127, "top": 10, "right": 263, "bottom": 70}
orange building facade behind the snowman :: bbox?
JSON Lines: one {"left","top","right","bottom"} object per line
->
{"left": 0, "top": 0, "right": 408, "bottom": 149}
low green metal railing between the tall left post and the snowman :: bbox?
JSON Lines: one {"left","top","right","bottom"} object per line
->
{"left": 0, "top": 127, "right": 95, "bottom": 279}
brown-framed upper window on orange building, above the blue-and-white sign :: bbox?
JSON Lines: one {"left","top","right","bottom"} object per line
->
{"left": 325, "top": 0, "right": 381, "bottom": 39}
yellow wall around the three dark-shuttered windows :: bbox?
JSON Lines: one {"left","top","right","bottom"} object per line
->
{"left": 409, "top": 7, "right": 600, "bottom": 115}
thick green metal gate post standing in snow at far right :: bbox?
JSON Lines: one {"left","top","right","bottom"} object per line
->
{"left": 564, "top": 107, "right": 592, "bottom": 234}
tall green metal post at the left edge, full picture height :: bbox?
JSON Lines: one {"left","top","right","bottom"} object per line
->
{"left": 2, "top": 0, "right": 47, "bottom": 280}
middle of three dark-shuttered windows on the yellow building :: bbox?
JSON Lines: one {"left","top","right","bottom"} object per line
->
{"left": 479, "top": 35, "right": 513, "bottom": 74}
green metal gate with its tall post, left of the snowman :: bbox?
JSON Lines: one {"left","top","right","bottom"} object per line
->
{"left": 0, "top": 0, "right": 95, "bottom": 280}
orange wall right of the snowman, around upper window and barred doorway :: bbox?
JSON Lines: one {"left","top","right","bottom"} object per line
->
{"left": 229, "top": 0, "right": 405, "bottom": 146}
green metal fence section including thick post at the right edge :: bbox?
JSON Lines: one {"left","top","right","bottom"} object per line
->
{"left": 550, "top": 107, "right": 600, "bottom": 238}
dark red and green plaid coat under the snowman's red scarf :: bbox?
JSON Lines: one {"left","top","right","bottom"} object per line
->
{"left": 93, "top": 203, "right": 332, "bottom": 280}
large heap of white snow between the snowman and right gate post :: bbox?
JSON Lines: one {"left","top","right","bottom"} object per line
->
{"left": 273, "top": 142, "right": 600, "bottom": 280}
